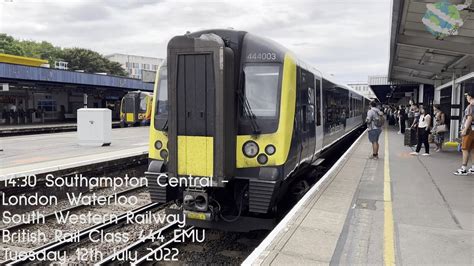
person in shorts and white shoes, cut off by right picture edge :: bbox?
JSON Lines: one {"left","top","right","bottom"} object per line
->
{"left": 454, "top": 91, "right": 474, "bottom": 175}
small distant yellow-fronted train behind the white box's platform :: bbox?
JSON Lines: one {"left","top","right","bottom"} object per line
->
{"left": 120, "top": 91, "right": 153, "bottom": 127}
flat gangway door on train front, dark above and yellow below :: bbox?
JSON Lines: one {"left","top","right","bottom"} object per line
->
{"left": 177, "top": 54, "right": 215, "bottom": 176}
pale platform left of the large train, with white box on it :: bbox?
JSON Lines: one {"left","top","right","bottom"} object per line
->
{"left": 0, "top": 127, "right": 149, "bottom": 180}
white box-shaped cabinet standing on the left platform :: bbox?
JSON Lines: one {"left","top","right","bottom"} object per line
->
{"left": 77, "top": 108, "right": 112, "bottom": 146}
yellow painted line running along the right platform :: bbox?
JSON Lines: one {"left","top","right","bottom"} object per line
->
{"left": 383, "top": 127, "right": 395, "bottom": 265}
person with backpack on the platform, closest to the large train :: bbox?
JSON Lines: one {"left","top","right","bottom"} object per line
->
{"left": 366, "top": 101, "right": 385, "bottom": 160}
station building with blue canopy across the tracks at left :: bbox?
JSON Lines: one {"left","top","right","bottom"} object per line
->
{"left": 0, "top": 54, "right": 153, "bottom": 125}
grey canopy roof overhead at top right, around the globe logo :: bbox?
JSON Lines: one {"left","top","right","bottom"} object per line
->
{"left": 388, "top": 0, "right": 474, "bottom": 85}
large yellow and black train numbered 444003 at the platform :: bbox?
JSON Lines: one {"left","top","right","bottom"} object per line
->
{"left": 145, "top": 29, "right": 369, "bottom": 231}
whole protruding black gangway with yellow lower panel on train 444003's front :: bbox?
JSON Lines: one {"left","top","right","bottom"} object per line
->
{"left": 167, "top": 34, "right": 236, "bottom": 187}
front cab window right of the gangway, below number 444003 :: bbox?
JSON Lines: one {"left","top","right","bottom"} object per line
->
{"left": 244, "top": 65, "right": 280, "bottom": 118}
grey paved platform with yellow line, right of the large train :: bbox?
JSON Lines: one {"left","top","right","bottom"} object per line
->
{"left": 243, "top": 130, "right": 474, "bottom": 265}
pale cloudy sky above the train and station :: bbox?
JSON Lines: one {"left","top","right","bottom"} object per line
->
{"left": 0, "top": 0, "right": 391, "bottom": 82}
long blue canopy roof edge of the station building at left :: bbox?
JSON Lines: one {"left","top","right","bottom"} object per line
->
{"left": 0, "top": 63, "right": 153, "bottom": 91}
